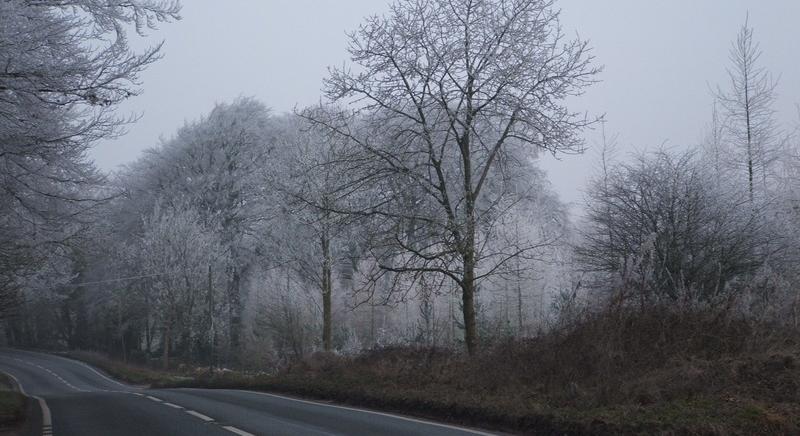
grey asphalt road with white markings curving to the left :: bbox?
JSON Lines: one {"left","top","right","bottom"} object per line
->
{"left": 0, "top": 349, "right": 488, "bottom": 436}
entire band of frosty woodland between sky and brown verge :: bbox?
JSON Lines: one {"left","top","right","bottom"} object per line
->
{"left": 0, "top": 0, "right": 800, "bottom": 368}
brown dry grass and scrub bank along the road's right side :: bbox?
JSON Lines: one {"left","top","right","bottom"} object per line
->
{"left": 162, "top": 310, "right": 800, "bottom": 435}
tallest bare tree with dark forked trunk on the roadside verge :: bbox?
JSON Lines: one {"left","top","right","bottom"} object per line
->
{"left": 304, "top": 0, "right": 599, "bottom": 353}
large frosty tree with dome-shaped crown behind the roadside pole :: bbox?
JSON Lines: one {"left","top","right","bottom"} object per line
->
{"left": 124, "top": 98, "right": 273, "bottom": 358}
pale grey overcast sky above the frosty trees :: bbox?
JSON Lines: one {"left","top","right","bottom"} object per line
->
{"left": 92, "top": 0, "right": 800, "bottom": 211}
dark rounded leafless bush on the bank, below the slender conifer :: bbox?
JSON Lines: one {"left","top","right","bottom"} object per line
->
{"left": 577, "top": 151, "right": 763, "bottom": 304}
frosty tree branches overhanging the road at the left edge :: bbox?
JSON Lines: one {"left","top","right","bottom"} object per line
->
{"left": 0, "top": 0, "right": 180, "bottom": 314}
